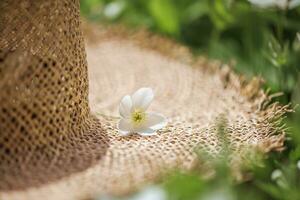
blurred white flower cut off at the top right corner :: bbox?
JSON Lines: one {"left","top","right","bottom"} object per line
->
{"left": 248, "top": 0, "right": 300, "bottom": 10}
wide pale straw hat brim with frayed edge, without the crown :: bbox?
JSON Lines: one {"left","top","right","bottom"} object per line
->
{"left": 0, "top": 25, "right": 288, "bottom": 199}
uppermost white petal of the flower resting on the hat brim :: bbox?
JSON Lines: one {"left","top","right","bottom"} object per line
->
{"left": 132, "top": 88, "right": 154, "bottom": 110}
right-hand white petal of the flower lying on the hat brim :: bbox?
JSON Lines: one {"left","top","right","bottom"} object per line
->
{"left": 146, "top": 112, "right": 168, "bottom": 130}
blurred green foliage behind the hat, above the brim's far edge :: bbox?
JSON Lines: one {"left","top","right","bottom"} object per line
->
{"left": 81, "top": 0, "right": 300, "bottom": 97}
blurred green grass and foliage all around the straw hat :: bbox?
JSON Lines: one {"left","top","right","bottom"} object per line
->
{"left": 81, "top": 0, "right": 300, "bottom": 200}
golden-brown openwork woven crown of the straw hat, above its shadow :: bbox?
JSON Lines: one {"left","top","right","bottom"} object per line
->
{"left": 0, "top": 0, "right": 89, "bottom": 141}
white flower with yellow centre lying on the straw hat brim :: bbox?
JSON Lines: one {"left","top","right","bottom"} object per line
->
{"left": 118, "top": 88, "right": 167, "bottom": 136}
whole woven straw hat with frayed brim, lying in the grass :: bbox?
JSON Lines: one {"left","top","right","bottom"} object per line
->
{"left": 0, "top": 0, "right": 288, "bottom": 200}
